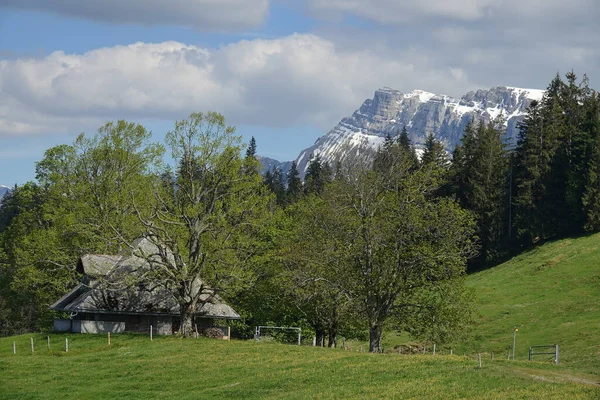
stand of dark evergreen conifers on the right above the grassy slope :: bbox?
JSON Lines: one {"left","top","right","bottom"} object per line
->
{"left": 447, "top": 72, "right": 600, "bottom": 268}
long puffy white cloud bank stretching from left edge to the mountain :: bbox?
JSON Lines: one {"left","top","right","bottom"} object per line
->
{"left": 0, "top": 34, "right": 476, "bottom": 136}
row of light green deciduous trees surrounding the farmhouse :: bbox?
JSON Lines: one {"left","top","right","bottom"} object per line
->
{"left": 0, "top": 113, "right": 474, "bottom": 351}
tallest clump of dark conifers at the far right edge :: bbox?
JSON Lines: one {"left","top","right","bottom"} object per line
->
{"left": 513, "top": 72, "right": 598, "bottom": 245}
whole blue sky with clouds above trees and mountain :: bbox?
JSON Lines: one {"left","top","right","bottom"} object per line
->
{"left": 0, "top": 0, "right": 600, "bottom": 185}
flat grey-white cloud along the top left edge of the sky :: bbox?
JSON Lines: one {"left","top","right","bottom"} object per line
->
{"left": 0, "top": 0, "right": 269, "bottom": 31}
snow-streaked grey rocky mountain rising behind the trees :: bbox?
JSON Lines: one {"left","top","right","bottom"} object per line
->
{"left": 296, "top": 86, "right": 544, "bottom": 176}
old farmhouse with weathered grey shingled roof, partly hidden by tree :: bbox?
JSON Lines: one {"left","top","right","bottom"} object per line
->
{"left": 50, "top": 239, "right": 240, "bottom": 335}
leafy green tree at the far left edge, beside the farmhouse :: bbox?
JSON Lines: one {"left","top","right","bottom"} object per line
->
{"left": 0, "top": 182, "right": 77, "bottom": 335}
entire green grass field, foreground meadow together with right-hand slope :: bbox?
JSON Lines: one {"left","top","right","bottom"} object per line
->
{"left": 0, "top": 235, "right": 600, "bottom": 399}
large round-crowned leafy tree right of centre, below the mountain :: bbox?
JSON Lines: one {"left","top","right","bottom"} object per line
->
{"left": 292, "top": 153, "right": 474, "bottom": 352}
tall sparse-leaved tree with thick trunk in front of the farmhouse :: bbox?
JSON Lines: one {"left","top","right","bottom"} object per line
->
{"left": 132, "top": 112, "right": 270, "bottom": 336}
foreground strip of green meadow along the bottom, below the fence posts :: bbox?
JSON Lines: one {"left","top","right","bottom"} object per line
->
{"left": 0, "top": 335, "right": 600, "bottom": 399}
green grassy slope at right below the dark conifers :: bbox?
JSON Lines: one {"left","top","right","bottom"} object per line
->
{"left": 461, "top": 234, "right": 600, "bottom": 373}
